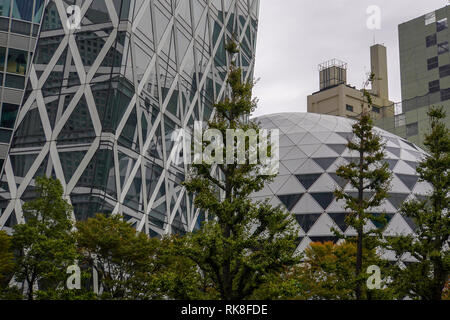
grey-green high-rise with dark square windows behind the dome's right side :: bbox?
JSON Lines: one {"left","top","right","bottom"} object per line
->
{"left": 376, "top": 6, "right": 450, "bottom": 147}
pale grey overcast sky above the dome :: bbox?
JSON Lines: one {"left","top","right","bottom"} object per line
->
{"left": 254, "top": 0, "right": 448, "bottom": 116}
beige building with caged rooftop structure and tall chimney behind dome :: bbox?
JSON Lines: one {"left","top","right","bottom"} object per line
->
{"left": 308, "top": 44, "right": 394, "bottom": 119}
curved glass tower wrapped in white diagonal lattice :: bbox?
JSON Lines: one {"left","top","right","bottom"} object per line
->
{"left": 0, "top": 0, "right": 259, "bottom": 236}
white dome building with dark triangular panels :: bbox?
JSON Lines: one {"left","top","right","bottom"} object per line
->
{"left": 254, "top": 113, "right": 430, "bottom": 251}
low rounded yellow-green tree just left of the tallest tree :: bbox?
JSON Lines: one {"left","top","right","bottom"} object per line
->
{"left": 76, "top": 214, "right": 163, "bottom": 299}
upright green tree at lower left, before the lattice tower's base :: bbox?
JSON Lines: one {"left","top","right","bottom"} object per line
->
{"left": 13, "top": 177, "right": 77, "bottom": 300}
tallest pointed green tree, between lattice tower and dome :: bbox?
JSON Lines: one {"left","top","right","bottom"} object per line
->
{"left": 181, "top": 42, "right": 298, "bottom": 300}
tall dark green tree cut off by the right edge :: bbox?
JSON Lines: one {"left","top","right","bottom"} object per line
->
{"left": 387, "top": 107, "right": 450, "bottom": 300}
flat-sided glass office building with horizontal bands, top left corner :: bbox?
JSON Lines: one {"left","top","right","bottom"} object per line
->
{"left": 0, "top": 0, "right": 45, "bottom": 171}
